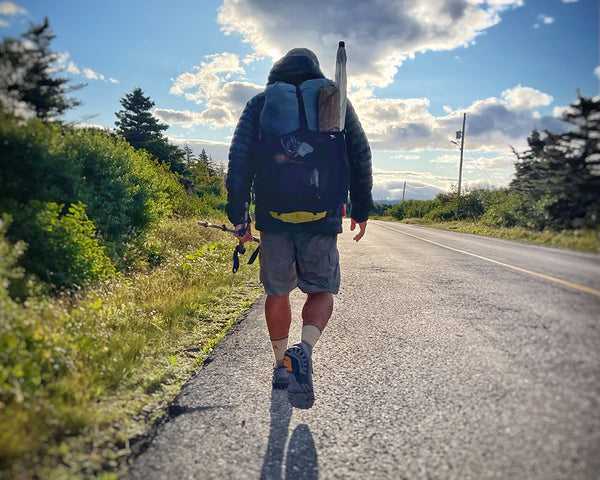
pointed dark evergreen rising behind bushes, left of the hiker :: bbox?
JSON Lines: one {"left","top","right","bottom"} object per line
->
{"left": 115, "top": 87, "right": 185, "bottom": 174}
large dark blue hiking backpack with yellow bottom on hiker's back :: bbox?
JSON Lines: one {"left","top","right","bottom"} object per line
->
{"left": 255, "top": 78, "right": 349, "bottom": 223}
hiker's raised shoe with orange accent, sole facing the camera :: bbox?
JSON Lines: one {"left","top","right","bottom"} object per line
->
{"left": 283, "top": 342, "right": 315, "bottom": 409}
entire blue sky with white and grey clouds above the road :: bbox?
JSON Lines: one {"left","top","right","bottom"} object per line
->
{"left": 0, "top": 0, "right": 600, "bottom": 200}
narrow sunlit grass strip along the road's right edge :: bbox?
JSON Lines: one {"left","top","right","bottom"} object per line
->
{"left": 378, "top": 217, "right": 600, "bottom": 252}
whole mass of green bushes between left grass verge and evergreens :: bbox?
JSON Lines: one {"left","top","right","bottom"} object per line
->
{"left": 0, "top": 112, "right": 206, "bottom": 287}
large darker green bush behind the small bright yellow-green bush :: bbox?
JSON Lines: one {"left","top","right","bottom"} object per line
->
{"left": 0, "top": 115, "right": 185, "bottom": 255}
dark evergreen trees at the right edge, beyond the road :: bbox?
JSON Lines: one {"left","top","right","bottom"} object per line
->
{"left": 511, "top": 93, "right": 600, "bottom": 229}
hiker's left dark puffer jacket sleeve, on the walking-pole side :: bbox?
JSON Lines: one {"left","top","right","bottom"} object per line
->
{"left": 225, "top": 94, "right": 264, "bottom": 225}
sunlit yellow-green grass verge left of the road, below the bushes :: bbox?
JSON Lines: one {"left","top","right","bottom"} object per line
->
{"left": 0, "top": 219, "right": 261, "bottom": 479}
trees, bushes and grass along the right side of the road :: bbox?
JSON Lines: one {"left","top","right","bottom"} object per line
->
{"left": 374, "top": 95, "right": 600, "bottom": 252}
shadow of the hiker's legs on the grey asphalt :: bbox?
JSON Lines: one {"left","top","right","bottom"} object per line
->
{"left": 260, "top": 389, "right": 319, "bottom": 480}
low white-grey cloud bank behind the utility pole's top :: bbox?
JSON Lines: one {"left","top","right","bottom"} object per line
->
{"left": 350, "top": 85, "right": 564, "bottom": 151}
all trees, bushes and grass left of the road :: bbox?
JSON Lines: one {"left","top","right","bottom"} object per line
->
{"left": 0, "top": 17, "right": 260, "bottom": 480}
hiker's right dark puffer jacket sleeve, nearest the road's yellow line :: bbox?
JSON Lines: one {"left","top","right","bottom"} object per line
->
{"left": 346, "top": 102, "right": 373, "bottom": 222}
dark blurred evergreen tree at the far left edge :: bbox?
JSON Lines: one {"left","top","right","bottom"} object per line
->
{"left": 0, "top": 18, "right": 85, "bottom": 120}
